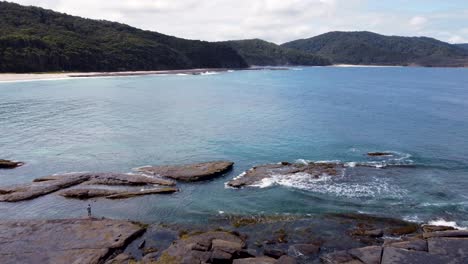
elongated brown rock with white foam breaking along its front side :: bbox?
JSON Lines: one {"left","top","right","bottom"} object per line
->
{"left": 228, "top": 163, "right": 344, "bottom": 188}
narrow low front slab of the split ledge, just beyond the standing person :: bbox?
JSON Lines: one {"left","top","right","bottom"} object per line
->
{"left": 59, "top": 187, "right": 178, "bottom": 200}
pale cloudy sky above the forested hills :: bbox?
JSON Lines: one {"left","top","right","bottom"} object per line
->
{"left": 9, "top": 0, "right": 468, "bottom": 44}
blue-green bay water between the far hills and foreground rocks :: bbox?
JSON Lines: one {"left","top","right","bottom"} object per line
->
{"left": 0, "top": 67, "right": 468, "bottom": 226}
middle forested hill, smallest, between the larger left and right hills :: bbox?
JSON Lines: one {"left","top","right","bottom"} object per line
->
{"left": 221, "top": 39, "right": 331, "bottom": 66}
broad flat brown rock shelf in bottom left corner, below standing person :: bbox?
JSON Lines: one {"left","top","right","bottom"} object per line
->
{"left": 0, "top": 219, "right": 144, "bottom": 264}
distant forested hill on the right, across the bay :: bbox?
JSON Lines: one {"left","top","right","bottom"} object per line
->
{"left": 282, "top": 32, "right": 468, "bottom": 66}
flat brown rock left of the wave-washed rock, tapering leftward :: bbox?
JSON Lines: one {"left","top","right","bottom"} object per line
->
{"left": 137, "top": 161, "right": 234, "bottom": 182}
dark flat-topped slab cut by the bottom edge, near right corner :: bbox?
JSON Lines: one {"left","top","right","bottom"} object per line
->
{"left": 381, "top": 247, "right": 456, "bottom": 264}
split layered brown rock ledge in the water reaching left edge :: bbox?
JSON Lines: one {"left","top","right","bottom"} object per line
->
{"left": 0, "top": 173, "right": 177, "bottom": 202}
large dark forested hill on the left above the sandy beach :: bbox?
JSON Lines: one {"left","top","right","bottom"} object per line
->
{"left": 0, "top": 2, "right": 247, "bottom": 72}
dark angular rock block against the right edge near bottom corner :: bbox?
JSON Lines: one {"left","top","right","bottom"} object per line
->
{"left": 427, "top": 237, "right": 468, "bottom": 258}
